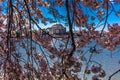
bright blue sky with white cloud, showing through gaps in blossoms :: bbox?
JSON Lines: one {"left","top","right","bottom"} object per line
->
{"left": 0, "top": 0, "right": 120, "bottom": 30}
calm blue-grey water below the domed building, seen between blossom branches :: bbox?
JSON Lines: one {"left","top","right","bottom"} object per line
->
{"left": 18, "top": 40, "right": 120, "bottom": 80}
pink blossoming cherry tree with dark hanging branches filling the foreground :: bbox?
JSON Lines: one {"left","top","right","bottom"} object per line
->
{"left": 0, "top": 0, "right": 120, "bottom": 80}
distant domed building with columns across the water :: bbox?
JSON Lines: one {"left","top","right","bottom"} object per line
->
{"left": 47, "top": 23, "right": 66, "bottom": 35}
